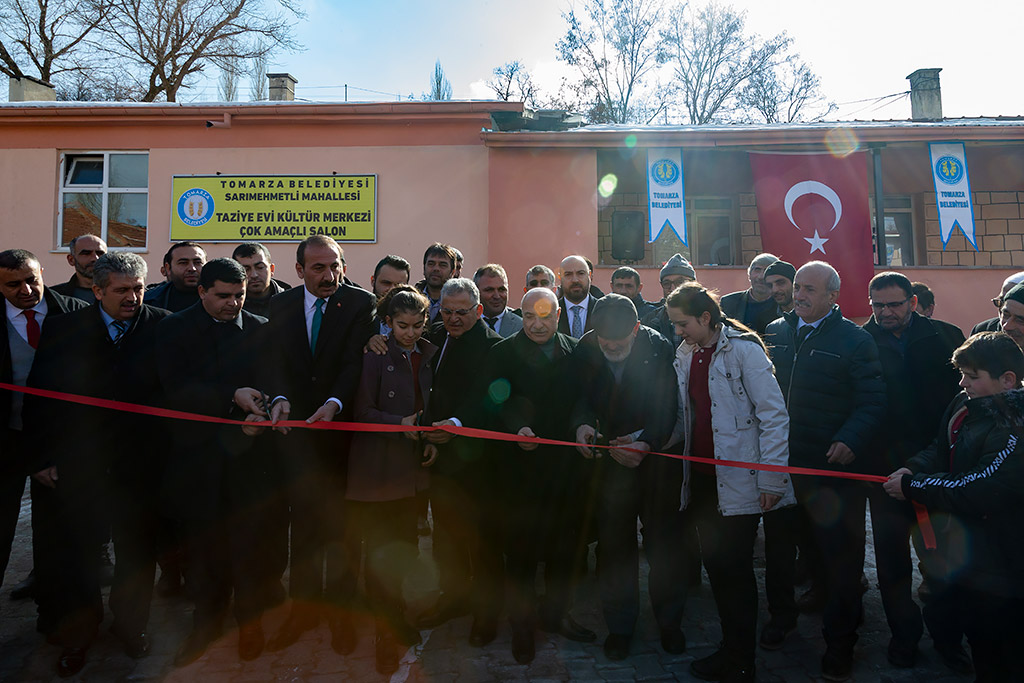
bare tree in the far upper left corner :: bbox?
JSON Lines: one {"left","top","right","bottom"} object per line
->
{"left": 0, "top": 0, "right": 108, "bottom": 84}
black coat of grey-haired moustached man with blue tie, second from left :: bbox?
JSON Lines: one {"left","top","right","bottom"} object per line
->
{"left": 25, "top": 302, "right": 169, "bottom": 487}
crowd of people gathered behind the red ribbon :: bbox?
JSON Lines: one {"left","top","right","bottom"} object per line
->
{"left": 0, "top": 236, "right": 1024, "bottom": 682}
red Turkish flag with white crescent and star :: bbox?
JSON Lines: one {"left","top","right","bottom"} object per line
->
{"left": 750, "top": 153, "right": 874, "bottom": 317}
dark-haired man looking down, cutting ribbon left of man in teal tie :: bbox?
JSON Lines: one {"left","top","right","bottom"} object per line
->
{"left": 157, "top": 258, "right": 272, "bottom": 666}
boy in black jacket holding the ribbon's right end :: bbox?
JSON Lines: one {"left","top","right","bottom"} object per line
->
{"left": 885, "top": 332, "right": 1024, "bottom": 681}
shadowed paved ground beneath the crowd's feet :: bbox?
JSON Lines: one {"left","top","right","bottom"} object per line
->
{"left": 0, "top": 491, "right": 969, "bottom": 683}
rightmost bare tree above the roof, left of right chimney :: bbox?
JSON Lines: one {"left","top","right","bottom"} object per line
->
{"left": 737, "top": 55, "right": 836, "bottom": 123}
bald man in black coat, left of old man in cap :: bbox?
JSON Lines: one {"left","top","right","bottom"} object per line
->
{"left": 487, "top": 288, "right": 597, "bottom": 664}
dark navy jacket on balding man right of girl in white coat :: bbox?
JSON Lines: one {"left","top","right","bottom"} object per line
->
{"left": 765, "top": 306, "right": 886, "bottom": 472}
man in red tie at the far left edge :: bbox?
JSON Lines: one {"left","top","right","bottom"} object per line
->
{"left": 0, "top": 249, "right": 85, "bottom": 593}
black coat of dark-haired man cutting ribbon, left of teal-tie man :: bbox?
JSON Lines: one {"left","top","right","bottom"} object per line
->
{"left": 157, "top": 303, "right": 266, "bottom": 519}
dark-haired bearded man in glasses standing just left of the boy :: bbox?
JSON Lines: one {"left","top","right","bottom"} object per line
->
{"left": 864, "top": 272, "right": 964, "bottom": 669}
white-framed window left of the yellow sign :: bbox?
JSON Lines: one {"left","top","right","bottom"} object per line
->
{"left": 57, "top": 152, "right": 150, "bottom": 250}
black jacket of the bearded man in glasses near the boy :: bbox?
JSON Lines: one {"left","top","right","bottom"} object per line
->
{"left": 858, "top": 313, "right": 964, "bottom": 474}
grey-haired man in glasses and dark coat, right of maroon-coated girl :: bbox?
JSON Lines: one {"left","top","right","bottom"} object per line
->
{"left": 419, "top": 278, "right": 502, "bottom": 647}
